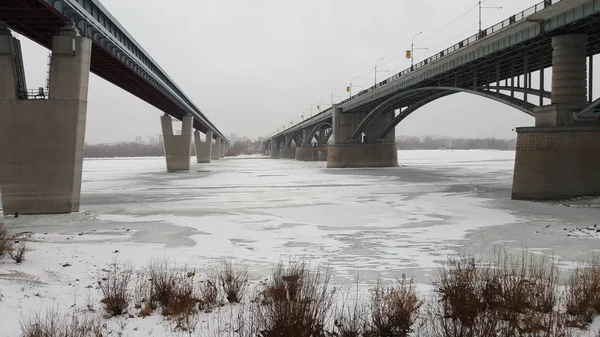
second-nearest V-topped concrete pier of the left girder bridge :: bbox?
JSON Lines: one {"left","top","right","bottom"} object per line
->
{"left": 160, "top": 114, "right": 194, "bottom": 172}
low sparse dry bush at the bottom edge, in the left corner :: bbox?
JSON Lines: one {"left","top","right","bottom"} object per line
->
{"left": 21, "top": 308, "right": 105, "bottom": 337}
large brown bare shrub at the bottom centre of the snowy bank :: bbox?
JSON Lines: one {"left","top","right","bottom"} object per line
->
{"left": 250, "top": 261, "right": 335, "bottom": 337}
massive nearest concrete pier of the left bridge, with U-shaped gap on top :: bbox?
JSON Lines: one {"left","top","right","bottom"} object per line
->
{"left": 0, "top": 28, "right": 92, "bottom": 215}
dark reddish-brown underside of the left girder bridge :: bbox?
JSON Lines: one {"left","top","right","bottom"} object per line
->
{"left": 0, "top": 0, "right": 208, "bottom": 133}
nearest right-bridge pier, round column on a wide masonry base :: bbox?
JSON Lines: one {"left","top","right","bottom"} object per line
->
{"left": 512, "top": 34, "right": 600, "bottom": 200}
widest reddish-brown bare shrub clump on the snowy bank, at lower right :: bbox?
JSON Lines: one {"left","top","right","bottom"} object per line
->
{"left": 434, "top": 251, "right": 564, "bottom": 336}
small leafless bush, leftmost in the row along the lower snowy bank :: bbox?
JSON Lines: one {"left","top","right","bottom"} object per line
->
{"left": 98, "top": 262, "right": 132, "bottom": 316}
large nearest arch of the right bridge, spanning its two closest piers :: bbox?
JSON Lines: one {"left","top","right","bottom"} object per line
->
{"left": 350, "top": 87, "right": 536, "bottom": 140}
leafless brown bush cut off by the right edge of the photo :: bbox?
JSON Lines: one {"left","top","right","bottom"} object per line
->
{"left": 565, "top": 256, "right": 600, "bottom": 328}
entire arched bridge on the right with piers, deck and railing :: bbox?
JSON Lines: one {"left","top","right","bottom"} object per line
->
{"left": 263, "top": 0, "right": 600, "bottom": 200}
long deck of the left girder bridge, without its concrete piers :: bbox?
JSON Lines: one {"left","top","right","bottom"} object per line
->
{"left": 0, "top": 0, "right": 226, "bottom": 139}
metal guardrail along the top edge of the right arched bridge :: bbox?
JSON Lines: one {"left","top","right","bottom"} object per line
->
{"left": 267, "top": 0, "right": 564, "bottom": 139}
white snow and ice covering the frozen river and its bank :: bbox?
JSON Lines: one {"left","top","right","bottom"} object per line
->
{"left": 0, "top": 150, "right": 600, "bottom": 336}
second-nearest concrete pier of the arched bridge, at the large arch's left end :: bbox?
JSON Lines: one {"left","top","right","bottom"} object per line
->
{"left": 327, "top": 107, "right": 398, "bottom": 168}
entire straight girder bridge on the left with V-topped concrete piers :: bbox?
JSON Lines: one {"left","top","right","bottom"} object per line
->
{"left": 0, "top": 0, "right": 229, "bottom": 214}
